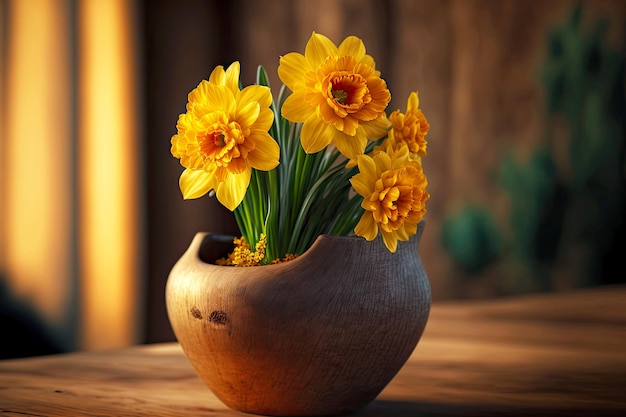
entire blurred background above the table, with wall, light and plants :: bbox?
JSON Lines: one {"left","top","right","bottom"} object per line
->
{"left": 0, "top": 0, "right": 626, "bottom": 358}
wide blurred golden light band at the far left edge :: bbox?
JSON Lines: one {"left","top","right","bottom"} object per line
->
{"left": 0, "top": 0, "right": 73, "bottom": 342}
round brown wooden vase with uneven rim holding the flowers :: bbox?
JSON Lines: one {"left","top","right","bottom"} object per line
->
{"left": 166, "top": 222, "right": 431, "bottom": 416}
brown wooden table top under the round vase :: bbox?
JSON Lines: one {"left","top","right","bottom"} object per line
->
{"left": 0, "top": 286, "right": 626, "bottom": 417}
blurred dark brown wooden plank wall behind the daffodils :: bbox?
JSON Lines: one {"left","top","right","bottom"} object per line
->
{"left": 141, "top": 0, "right": 626, "bottom": 342}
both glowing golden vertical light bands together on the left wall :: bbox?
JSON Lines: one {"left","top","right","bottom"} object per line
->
{"left": 0, "top": 0, "right": 143, "bottom": 350}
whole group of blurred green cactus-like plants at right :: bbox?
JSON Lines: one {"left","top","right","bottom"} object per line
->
{"left": 442, "top": 3, "right": 626, "bottom": 290}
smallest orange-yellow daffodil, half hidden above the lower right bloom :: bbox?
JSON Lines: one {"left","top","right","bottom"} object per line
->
{"left": 388, "top": 92, "right": 430, "bottom": 159}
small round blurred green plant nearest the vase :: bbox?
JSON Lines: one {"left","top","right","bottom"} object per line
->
{"left": 441, "top": 205, "right": 502, "bottom": 274}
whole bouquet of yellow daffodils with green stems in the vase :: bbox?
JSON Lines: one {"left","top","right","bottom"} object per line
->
{"left": 171, "top": 32, "right": 430, "bottom": 266}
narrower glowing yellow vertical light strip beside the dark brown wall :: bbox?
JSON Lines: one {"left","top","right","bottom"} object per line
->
{"left": 78, "top": 0, "right": 141, "bottom": 349}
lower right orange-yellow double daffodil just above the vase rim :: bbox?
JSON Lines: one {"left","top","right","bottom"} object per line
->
{"left": 350, "top": 145, "right": 430, "bottom": 252}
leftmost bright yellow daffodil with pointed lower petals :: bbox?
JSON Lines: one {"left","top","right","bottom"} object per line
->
{"left": 171, "top": 62, "right": 280, "bottom": 210}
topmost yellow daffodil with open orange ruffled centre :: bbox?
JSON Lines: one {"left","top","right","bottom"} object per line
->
{"left": 278, "top": 32, "right": 391, "bottom": 160}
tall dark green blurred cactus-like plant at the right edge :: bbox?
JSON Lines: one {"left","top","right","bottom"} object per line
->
{"left": 540, "top": 3, "right": 626, "bottom": 284}
